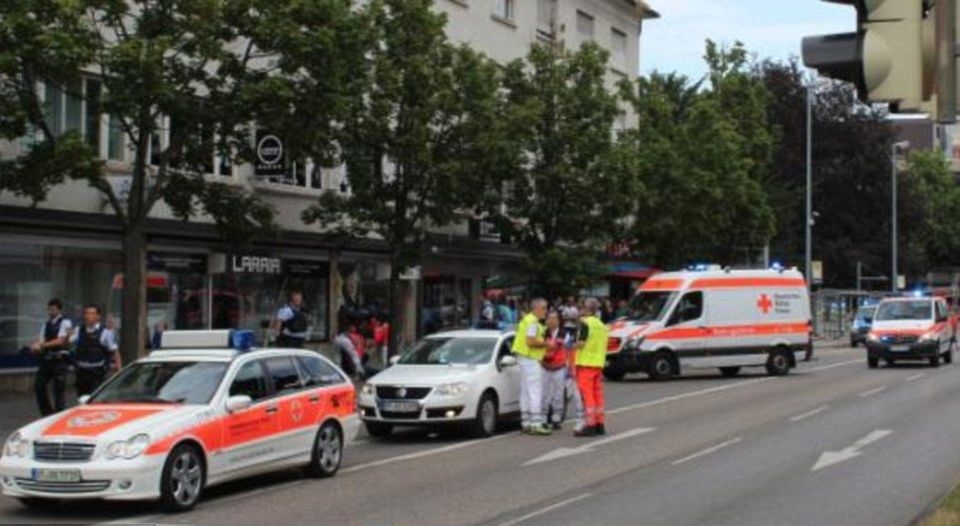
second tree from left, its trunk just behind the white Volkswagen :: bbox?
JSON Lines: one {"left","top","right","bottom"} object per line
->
{"left": 303, "top": 0, "right": 503, "bottom": 354}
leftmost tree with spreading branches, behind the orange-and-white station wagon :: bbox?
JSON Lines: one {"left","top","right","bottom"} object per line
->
{"left": 0, "top": 0, "right": 355, "bottom": 359}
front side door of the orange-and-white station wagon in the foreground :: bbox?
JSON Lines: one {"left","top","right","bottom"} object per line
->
{"left": 218, "top": 360, "right": 278, "bottom": 474}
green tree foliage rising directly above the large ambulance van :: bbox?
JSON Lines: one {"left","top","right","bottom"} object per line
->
{"left": 627, "top": 41, "right": 775, "bottom": 268}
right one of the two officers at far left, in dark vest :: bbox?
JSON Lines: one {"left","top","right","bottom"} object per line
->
{"left": 70, "top": 305, "right": 121, "bottom": 396}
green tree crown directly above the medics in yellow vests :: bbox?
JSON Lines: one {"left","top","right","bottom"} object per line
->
{"left": 494, "top": 43, "right": 638, "bottom": 300}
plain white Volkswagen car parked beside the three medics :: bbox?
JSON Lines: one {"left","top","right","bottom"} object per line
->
{"left": 358, "top": 330, "right": 520, "bottom": 436}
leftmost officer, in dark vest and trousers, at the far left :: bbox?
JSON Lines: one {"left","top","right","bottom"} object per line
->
{"left": 30, "top": 298, "right": 73, "bottom": 416}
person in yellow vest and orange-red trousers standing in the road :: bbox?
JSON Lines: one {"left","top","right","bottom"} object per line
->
{"left": 575, "top": 298, "right": 609, "bottom": 437}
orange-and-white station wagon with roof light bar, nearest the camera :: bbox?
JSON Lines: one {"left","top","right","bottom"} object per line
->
{"left": 0, "top": 331, "right": 359, "bottom": 511}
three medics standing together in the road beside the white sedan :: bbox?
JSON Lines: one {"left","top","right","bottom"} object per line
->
{"left": 512, "top": 298, "right": 608, "bottom": 437}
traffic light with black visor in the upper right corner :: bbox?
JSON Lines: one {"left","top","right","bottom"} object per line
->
{"left": 803, "top": 0, "right": 937, "bottom": 112}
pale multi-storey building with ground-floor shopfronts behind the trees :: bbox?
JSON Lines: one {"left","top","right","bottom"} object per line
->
{"left": 0, "top": 0, "right": 656, "bottom": 380}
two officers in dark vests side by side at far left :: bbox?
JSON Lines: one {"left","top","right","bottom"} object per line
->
{"left": 26, "top": 298, "right": 121, "bottom": 416}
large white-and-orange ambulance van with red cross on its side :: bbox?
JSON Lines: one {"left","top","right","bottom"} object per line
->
{"left": 604, "top": 266, "right": 813, "bottom": 380}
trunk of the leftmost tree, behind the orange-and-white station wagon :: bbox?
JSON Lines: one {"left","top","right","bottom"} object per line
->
{"left": 120, "top": 229, "right": 147, "bottom": 370}
